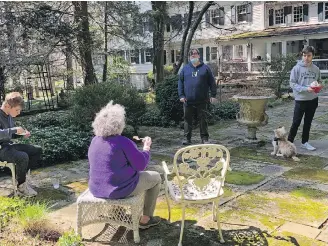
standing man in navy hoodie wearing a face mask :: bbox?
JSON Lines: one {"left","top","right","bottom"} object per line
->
{"left": 178, "top": 49, "right": 216, "bottom": 145}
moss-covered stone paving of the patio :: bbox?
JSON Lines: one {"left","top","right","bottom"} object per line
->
{"left": 0, "top": 92, "right": 328, "bottom": 246}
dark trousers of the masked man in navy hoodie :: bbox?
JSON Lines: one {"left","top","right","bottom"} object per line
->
{"left": 183, "top": 103, "right": 209, "bottom": 141}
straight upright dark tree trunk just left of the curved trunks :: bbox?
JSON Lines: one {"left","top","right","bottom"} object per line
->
{"left": 151, "top": 1, "right": 166, "bottom": 83}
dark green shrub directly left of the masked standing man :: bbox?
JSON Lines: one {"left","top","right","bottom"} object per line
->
{"left": 156, "top": 75, "right": 183, "bottom": 124}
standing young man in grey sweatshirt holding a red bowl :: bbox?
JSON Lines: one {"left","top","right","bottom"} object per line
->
{"left": 288, "top": 46, "right": 321, "bottom": 150}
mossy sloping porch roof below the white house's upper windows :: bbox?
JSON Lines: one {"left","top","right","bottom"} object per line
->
{"left": 217, "top": 24, "right": 328, "bottom": 41}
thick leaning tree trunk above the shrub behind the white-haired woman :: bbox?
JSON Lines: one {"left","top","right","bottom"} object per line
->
{"left": 72, "top": 1, "right": 97, "bottom": 85}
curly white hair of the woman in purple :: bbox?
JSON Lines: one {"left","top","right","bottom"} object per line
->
{"left": 92, "top": 101, "right": 125, "bottom": 137}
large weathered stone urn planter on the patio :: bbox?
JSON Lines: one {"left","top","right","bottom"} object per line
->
{"left": 233, "top": 95, "right": 273, "bottom": 140}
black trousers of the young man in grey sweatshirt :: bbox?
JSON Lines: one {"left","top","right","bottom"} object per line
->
{"left": 288, "top": 98, "right": 318, "bottom": 144}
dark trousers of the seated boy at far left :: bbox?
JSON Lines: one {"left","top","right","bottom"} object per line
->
{"left": 0, "top": 144, "right": 42, "bottom": 185}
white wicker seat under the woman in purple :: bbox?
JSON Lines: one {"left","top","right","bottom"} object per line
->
{"left": 77, "top": 189, "right": 145, "bottom": 243}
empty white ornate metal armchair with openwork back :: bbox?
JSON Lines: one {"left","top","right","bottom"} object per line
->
{"left": 163, "top": 144, "right": 231, "bottom": 246}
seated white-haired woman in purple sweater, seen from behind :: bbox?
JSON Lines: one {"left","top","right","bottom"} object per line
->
{"left": 88, "top": 101, "right": 161, "bottom": 229}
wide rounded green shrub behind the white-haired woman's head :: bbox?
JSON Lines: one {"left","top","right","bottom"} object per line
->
{"left": 72, "top": 82, "right": 146, "bottom": 130}
